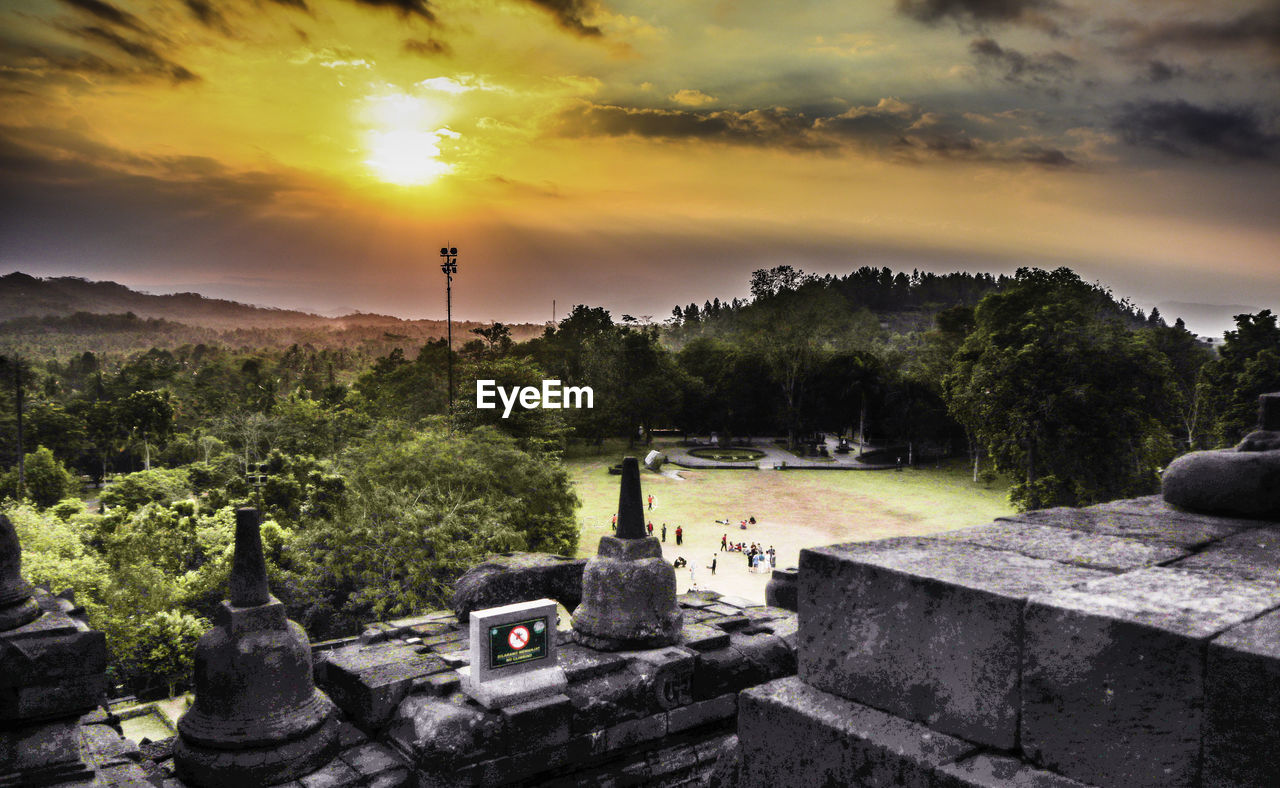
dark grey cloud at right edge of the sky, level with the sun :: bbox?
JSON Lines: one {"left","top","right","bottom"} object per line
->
{"left": 1114, "top": 100, "right": 1280, "bottom": 161}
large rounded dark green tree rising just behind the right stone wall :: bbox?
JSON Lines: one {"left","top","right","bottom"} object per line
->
{"left": 945, "top": 269, "right": 1172, "bottom": 508}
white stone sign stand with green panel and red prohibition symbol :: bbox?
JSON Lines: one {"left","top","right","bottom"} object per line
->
{"left": 458, "top": 599, "right": 566, "bottom": 709}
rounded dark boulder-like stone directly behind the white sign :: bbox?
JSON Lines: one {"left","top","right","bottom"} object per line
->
{"left": 450, "top": 553, "right": 586, "bottom": 621}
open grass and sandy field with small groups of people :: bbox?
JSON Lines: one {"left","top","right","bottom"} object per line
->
{"left": 566, "top": 449, "right": 1012, "bottom": 601}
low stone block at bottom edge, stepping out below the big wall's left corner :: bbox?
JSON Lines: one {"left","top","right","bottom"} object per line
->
{"left": 737, "top": 677, "right": 975, "bottom": 788}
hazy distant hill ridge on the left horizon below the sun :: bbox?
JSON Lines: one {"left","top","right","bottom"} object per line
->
{"left": 0, "top": 271, "right": 543, "bottom": 351}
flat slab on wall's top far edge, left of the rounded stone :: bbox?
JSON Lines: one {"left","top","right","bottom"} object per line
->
{"left": 997, "top": 507, "right": 1258, "bottom": 550}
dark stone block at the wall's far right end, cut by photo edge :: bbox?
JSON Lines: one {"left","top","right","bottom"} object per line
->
{"left": 1203, "top": 611, "right": 1280, "bottom": 788}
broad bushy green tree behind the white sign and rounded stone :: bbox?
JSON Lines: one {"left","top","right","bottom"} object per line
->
{"left": 297, "top": 420, "right": 577, "bottom": 633}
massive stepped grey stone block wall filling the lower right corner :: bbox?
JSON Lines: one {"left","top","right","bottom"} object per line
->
{"left": 727, "top": 496, "right": 1280, "bottom": 788}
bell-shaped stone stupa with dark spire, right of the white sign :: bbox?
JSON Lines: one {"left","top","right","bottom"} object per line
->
{"left": 573, "top": 457, "right": 684, "bottom": 651}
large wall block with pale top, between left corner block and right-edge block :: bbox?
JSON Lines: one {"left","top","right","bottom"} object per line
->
{"left": 1021, "top": 567, "right": 1280, "bottom": 788}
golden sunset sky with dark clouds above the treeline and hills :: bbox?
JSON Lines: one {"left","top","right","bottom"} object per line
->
{"left": 0, "top": 0, "right": 1280, "bottom": 330}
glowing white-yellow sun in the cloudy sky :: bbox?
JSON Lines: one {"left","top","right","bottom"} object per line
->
{"left": 365, "top": 93, "right": 458, "bottom": 185}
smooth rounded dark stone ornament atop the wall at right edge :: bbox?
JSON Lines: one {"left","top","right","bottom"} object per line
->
{"left": 1162, "top": 393, "right": 1280, "bottom": 517}
